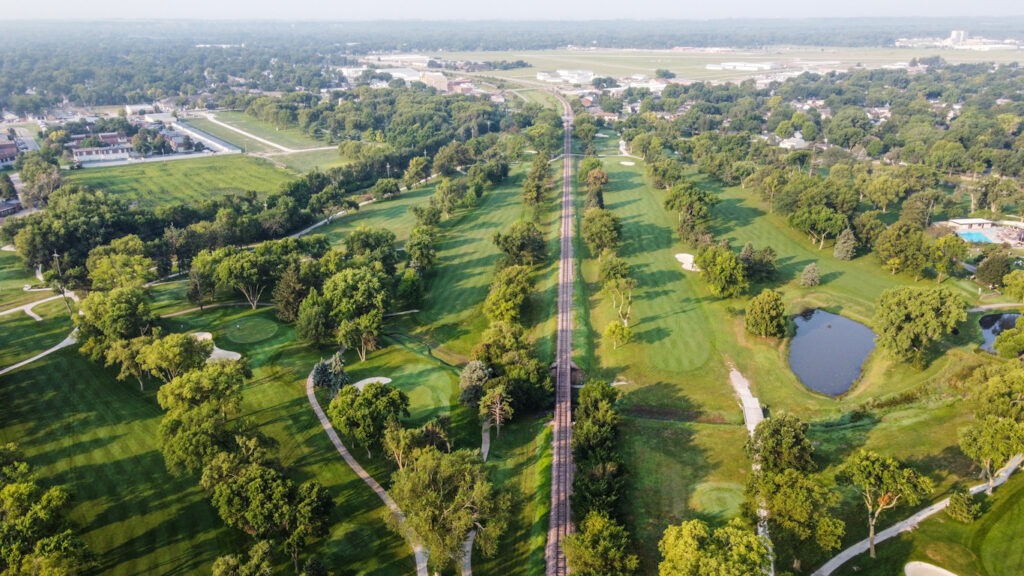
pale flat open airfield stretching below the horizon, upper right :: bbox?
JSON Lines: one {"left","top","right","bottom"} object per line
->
{"left": 442, "top": 46, "right": 1024, "bottom": 82}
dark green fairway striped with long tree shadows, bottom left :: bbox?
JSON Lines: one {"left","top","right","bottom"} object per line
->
{"left": 0, "top": 348, "right": 234, "bottom": 574}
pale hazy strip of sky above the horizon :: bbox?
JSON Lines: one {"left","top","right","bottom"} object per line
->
{"left": 12, "top": 0, "right": 1024, "bottom": 20}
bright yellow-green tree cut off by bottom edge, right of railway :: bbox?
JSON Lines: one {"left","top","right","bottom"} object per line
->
{"left": 657, "top": 520, "right": 771, "bottom": 576}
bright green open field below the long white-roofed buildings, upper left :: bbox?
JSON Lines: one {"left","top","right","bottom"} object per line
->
{"left": 68, "top": 155, "right": 293, "bottom": 208}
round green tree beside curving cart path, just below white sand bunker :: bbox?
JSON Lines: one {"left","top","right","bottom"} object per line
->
{"left": 327, "top": 382, "right": 409, "bottom": 457}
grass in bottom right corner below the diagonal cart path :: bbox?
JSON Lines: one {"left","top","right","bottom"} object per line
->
{"left": 836, "top": 472, "right": 1024, "bottom": 576}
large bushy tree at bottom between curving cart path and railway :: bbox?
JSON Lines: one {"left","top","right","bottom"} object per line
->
{"left": 391, "top": 449, "right": 512, "bottom": 570}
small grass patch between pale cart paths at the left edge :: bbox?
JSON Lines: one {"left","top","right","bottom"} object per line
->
{"left": 0, "top": 300, "right": 74, "bottom": 368}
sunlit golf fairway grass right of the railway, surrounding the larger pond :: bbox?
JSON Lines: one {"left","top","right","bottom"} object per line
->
{"left": 577, "top": 146, "right": 1003, "bottom": 573}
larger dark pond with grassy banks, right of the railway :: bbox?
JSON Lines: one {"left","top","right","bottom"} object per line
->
{"left": 790, "top": 310, "right": 874, "bottom": 396}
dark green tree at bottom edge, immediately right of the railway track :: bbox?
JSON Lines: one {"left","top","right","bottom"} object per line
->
{"left": 562, "top": 510, "right": 640, "bottom": 576}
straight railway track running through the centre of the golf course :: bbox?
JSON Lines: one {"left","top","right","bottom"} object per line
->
{"left": 544, "top": 91, "right": 574, "bottom": 576}
